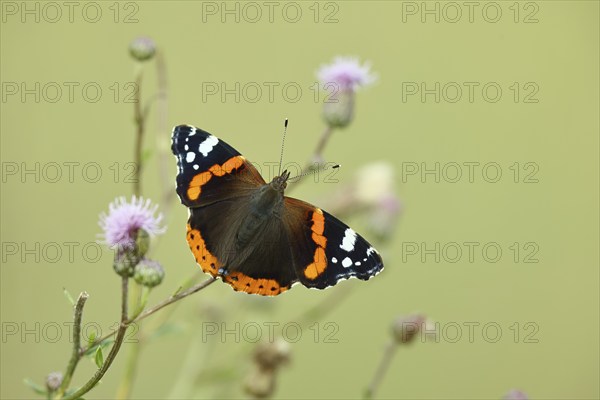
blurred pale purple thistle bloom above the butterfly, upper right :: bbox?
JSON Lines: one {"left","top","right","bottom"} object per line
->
{"left": 317, "top": 57, "right": 377, "bottom": 90}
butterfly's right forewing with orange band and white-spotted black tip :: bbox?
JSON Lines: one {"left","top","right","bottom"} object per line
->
{"left": 284, "top": 197, "right": 383, "bottom": 289}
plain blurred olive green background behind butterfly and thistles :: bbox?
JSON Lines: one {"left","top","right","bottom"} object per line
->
{"left": 0, "top": 1, "right": 600, "bottom": 399}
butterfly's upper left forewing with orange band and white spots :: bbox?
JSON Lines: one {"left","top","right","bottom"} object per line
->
{"left": 171, "top": 125, "right": 265, "bottom": 207}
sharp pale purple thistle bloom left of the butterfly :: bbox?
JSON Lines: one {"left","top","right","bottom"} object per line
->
{"left": 99, "top": 196, "right": 165, "bottom": 249}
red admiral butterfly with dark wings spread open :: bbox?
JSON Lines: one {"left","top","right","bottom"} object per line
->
{"left": 171, "top": 125, "right": 383, "bottom": 296}
